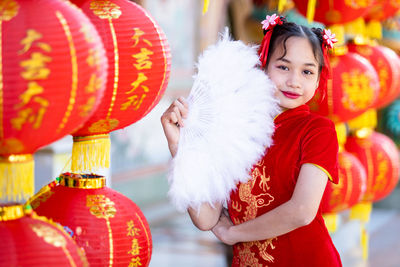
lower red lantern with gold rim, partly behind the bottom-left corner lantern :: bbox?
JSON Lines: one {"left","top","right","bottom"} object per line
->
{"left": 30, "top": 173, "right": 152, "bottom": 266}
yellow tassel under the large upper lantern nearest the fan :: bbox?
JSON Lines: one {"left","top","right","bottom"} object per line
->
{"left": 71, "top": 134, "right": 111, "bottom": 173}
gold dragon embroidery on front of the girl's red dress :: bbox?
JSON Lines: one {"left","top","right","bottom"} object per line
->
{"left": 236, "top": 161, "right": 277, "bottom": 266}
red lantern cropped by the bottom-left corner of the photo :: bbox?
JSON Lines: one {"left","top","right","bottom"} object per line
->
{"left": 0, "top": 205, "right": 89, "bottom": 267}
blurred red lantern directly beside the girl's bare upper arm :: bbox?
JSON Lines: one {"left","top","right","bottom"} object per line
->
{"left": 321, "top": 151, "right": 366, "bottom": 213}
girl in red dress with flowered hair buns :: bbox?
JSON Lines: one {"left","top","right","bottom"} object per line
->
{"left": 161, "top": 15, "right": 341, "bottom": 267}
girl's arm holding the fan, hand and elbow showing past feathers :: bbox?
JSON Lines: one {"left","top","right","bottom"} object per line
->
{"left": 161, "top": 97, "right": 222, "bottom": 231}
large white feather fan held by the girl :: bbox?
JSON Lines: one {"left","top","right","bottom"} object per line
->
{"left": 168, "top": 28, "right": 279, "bottom": 214}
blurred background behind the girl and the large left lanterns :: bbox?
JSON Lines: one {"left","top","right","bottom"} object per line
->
{"left": 27, "top": 0, "right": 400, "bottom": 267}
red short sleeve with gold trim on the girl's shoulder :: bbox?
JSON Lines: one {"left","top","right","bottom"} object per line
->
{"left": 300, "top": 118, "right": 339, "bottom": 184}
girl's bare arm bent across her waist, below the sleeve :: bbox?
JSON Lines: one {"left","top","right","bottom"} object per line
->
{"left": 213, "top": 163, "right": 328, "bottom": 245}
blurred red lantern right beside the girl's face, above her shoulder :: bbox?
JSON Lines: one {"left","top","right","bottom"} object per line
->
{"left": 310, "top": 52, "right": 379, "bottom": 123}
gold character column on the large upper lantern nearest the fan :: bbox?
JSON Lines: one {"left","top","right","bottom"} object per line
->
{"left": 120, "top": 28, "right": 154, "bottom": 113}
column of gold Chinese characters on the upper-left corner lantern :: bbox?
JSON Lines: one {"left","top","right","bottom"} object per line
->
{"left": 11, "top": 29, "right": 52, "bottom": 130}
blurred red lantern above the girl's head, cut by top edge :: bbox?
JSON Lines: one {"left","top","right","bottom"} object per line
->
{"left": 294, "top": 0, "right": 376, "bottom": 25}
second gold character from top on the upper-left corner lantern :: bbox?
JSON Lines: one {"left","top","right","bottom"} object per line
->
{"left": 20, "top": 52, "right": 52, "bottom": 80}
